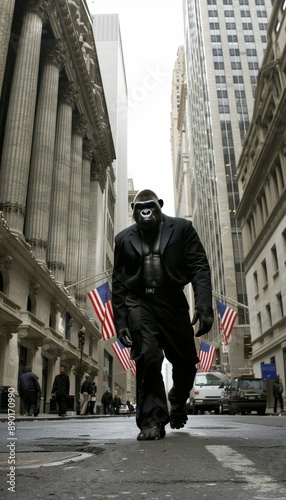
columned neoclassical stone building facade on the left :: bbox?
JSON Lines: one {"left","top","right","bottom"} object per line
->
{"left": 0, "top": 0, "right": 115, "bottom": 411}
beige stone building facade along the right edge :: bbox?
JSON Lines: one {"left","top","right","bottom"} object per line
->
{"left": 237, "top": 2, "right": 286, "bottom": 387}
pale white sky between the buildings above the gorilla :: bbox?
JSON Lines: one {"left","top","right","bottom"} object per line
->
{"left": 87, "top": 0, "right": 183, "bottom": 215}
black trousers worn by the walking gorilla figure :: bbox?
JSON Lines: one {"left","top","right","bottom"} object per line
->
{"left": 126, "top": 291, "right": 199, "bottom": 429}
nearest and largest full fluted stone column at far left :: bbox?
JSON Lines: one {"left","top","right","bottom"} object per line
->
{"left": 0, "top": 0, "right": 47, "bottom": 233}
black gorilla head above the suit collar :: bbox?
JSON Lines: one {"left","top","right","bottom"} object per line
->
{"left": 131, "top": 189, "right": 164, "bottom": 232}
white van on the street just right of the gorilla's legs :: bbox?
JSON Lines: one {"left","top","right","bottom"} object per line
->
{"left": 187, "top": 372, "right": 230, "bottom": 415}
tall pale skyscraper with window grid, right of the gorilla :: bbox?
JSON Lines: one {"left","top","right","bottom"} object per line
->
{"left": 177, "top": 0, "right": 272, "bottom": 373}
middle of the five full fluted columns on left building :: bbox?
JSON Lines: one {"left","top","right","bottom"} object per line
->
{"left": 47, "top": 83, "right": 77, "bottom": 283}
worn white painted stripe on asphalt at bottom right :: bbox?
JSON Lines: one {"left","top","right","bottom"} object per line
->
{"left": 206, "top": 445, "right": 286, "bottom": 499}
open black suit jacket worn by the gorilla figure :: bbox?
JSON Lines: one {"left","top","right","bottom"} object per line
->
{"left": 112, "top": 215, "right": 212, "bottom": 331}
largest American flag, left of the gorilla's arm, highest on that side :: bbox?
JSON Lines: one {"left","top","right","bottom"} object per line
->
{"left": 87, "top": 281, "right": 116, "bottom": 340}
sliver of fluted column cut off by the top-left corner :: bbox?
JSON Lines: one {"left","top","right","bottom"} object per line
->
{"left": 0, "top": 0, "right": 15, "bottom": 95}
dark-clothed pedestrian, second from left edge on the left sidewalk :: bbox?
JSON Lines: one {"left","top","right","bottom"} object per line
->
{"left": 18, "top": 366, "right": 42, "bottom": 417}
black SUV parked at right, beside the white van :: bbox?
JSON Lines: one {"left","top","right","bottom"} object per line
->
{"left": 223, "top": 375, "right": 266, "bottom": 415}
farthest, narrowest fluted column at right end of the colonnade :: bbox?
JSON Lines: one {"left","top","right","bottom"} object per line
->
{"left": 76, "top": 141, "right": 92, "bottom": 309}
